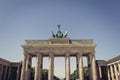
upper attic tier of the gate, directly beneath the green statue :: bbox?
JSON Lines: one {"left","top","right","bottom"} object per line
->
{"left": 25, "top": 38, "right": 93, "bottom": 45}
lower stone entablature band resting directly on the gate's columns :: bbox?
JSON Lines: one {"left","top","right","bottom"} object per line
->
{"left": 24, "top": 46, "right": 94, "bottom": 56}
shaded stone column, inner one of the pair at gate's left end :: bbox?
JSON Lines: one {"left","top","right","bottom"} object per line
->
{"left": 25, "top": 53, "right": 32, "bottom": 80}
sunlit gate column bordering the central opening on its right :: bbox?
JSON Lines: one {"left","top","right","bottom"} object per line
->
{"left": 65, "top": 53, "right": 70, "bottom": 80}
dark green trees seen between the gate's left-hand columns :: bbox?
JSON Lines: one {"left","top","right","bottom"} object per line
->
{"left": 31, "top": 67, "right": 60, "bottom": 80}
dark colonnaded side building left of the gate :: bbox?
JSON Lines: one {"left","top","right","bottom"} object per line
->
{"left": 0, "top": 58, "right": 21, "bottom": 80}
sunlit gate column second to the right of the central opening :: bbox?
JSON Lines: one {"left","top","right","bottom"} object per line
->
{"left": 77, "top": 53, "right": 84, "bottom": 80}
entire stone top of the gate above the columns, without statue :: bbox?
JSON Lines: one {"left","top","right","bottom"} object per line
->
{"left": 22, "top": 38, "right": 96, "bottom": 56}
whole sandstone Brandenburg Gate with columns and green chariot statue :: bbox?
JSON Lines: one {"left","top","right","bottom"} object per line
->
{"left": 21, "top": 26, "right": 97, "bottom": 80}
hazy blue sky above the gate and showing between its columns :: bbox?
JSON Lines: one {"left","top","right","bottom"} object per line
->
{"left": 0, "top": 0, "right": 120, "bottom": 76}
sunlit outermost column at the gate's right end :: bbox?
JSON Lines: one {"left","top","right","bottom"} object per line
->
{"left": 90, "top": 52, "right": 97, "bottom": 80}
